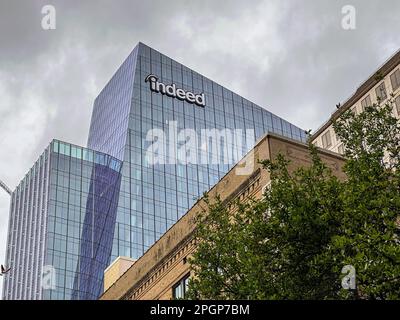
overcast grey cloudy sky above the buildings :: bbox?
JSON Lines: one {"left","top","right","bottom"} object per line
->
{"left": 0, "top": 0, "right": 400, "bottom": 298}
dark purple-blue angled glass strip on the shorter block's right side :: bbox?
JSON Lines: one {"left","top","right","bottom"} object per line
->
{"left": 72, "top": 158, "right": 121, "bottom": 300}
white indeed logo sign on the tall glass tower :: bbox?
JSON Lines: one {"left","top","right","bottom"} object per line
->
{"left": 144, "top": 74, "right": 206, "bottom": 107}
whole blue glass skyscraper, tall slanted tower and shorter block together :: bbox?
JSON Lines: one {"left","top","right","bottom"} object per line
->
{"left": 3, "top": 43, "right": 305, "bottom": 299}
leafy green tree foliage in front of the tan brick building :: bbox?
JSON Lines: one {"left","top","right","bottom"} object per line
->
{"left": 189, "top": 96, "right": 400, "bottom": 299}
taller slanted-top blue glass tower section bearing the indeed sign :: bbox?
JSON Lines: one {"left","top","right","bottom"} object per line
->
{"left": 88, "top": 43, "right": 305, "bottom": 260}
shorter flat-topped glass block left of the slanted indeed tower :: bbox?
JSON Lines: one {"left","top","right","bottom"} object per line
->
{"left": 3, "top": 140, "right": 121, "bottom": 300}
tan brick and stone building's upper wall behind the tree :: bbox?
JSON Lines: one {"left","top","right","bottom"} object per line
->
{"left": 101, "top": 135, "right": 343, "bottom": 300}
